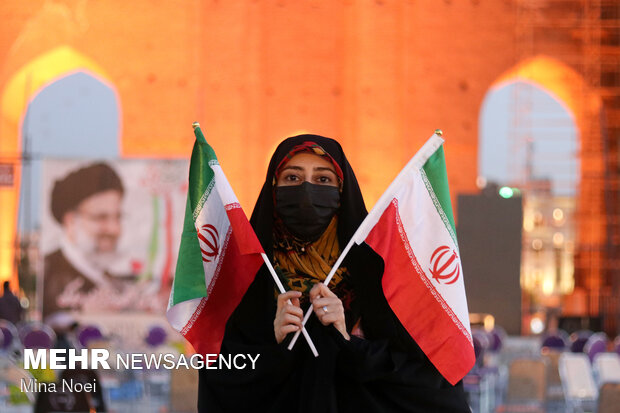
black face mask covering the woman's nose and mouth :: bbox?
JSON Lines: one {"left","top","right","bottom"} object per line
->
{"left": 275, "top": 182, "right": 340, "bottom": 241}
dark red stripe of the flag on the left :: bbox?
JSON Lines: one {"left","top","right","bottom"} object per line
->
{"left": 183, "top": 205, "right": 263, "bottom": 354}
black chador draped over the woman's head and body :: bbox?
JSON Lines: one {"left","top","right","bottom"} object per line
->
{"left": 198, "top": 135, "right": 470, "bottom": 413}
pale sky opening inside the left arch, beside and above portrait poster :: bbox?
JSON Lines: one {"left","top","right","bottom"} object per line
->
{"left": 19, "top": 71, "right": 120, "bottom": 233}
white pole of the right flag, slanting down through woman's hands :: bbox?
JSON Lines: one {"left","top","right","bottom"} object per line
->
{"left": 288, "top": 129, "right": 444, "bottom": 350}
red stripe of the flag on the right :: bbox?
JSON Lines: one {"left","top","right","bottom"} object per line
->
{"left": 366, "top": 200, "right": 475, "bottom": 385}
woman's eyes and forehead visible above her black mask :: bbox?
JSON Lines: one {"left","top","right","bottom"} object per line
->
{"left": 276, "top": 153, "right": 338, "bottom": 186}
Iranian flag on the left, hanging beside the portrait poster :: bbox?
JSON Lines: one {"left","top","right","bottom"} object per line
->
{"left": 167, "top": 123, "right": 263, "bottom": 354}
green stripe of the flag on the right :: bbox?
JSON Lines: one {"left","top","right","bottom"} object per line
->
{"left": 421, "top": 145, "right": 458, "bottom": 246}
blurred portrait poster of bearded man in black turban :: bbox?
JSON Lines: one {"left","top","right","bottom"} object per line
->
{"left": 39, "top": 159, "right": 188, "bottom": 318}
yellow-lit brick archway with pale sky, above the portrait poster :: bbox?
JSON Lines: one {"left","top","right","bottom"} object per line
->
{"left": 0, "top": 46, "right": 121, "bottom": 285}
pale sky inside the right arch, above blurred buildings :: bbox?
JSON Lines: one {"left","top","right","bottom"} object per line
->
{"left": 478, "top": 80, "right": 581, "bottom": 197}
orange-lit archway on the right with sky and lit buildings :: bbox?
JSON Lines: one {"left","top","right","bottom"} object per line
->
{"left": 479, "top": 56, "right": 606, "bottom": 329}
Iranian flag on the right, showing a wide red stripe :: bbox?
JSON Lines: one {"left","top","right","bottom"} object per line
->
{"left": 353, "top": 134, "right": 475, "bottom": 384}
